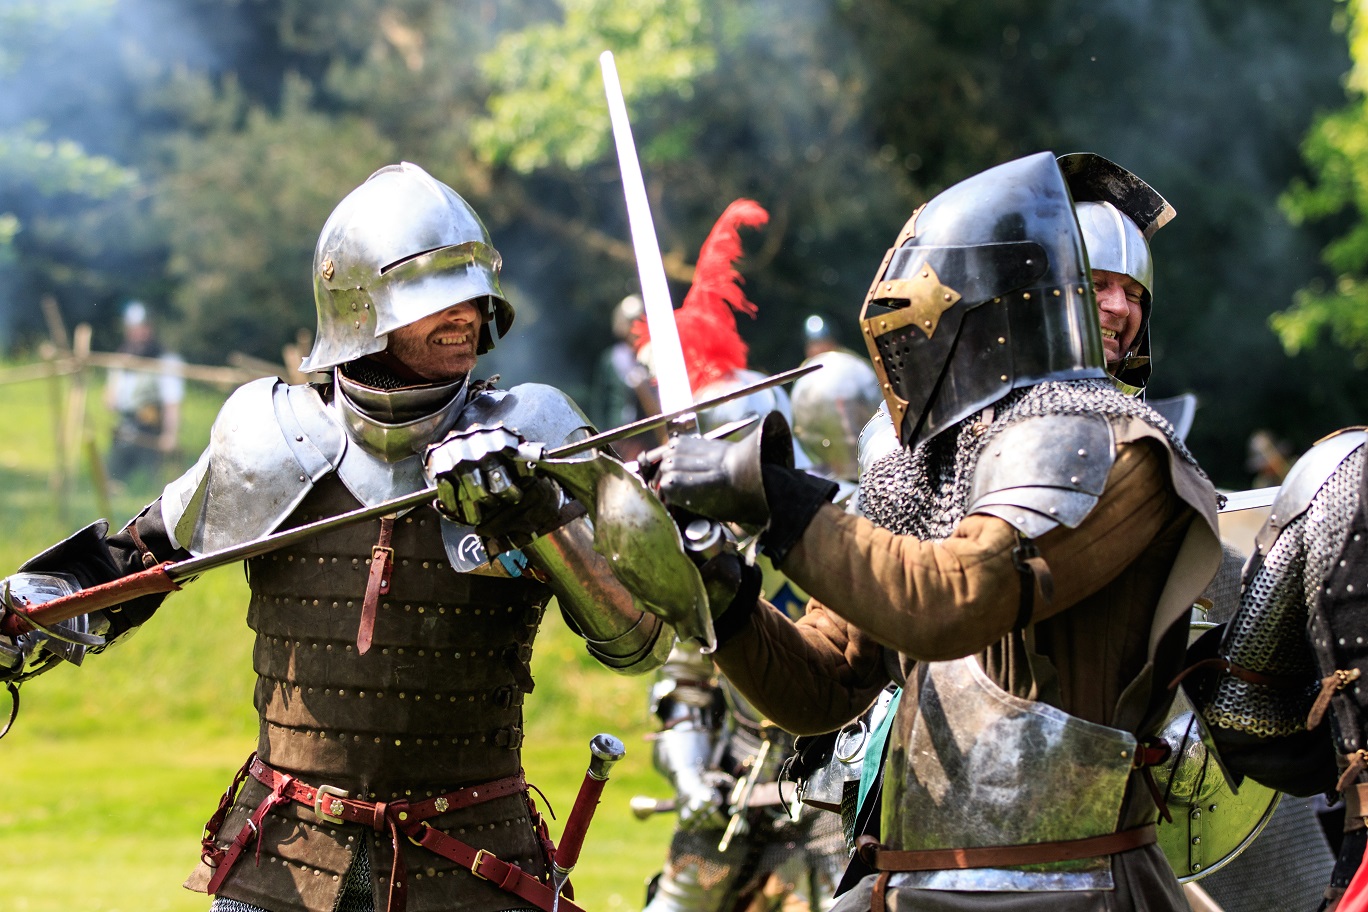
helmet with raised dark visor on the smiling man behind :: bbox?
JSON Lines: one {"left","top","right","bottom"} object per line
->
{"left": 1059, "top": 152, "right": 1176, "bottom": 391}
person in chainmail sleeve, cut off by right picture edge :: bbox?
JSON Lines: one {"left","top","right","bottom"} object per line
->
{"left": 1185, "top": 428, "right": 1368, "bottom": 908}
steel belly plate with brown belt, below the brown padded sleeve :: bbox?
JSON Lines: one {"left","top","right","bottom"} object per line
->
{"left": 882, "top": 656, "right": 1135, "bottom": 891}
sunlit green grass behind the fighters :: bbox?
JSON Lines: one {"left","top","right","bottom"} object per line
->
{"left": 0, "top": 371, "right": 672, "bottom": 912}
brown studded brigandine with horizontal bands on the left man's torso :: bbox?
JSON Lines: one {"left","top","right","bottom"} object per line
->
{"left": 186, "top": 476, "right": 550, "bottom": 912}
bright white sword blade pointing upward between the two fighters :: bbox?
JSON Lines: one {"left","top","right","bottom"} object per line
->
{"left": 599, "top": 51, "right": 694, "bottom": 413}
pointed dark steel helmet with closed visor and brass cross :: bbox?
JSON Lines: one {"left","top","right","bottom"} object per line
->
{"left": 860, "top": 152, "right": 1107, "bottom": 447}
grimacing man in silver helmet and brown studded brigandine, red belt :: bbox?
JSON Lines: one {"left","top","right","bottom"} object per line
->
{"left": 0, "top": 163, "right": 674, "bottom": 912}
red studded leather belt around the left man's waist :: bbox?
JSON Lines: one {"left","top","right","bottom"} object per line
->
{"left": 204, "top": 755, "right": 584, "bottom": 912}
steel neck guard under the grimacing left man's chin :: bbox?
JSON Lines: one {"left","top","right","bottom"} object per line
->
{"left": 337, "top": 369, "right": 471, "bottom": 462}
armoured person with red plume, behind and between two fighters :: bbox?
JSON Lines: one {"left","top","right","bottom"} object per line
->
{"left": 646, "top": 200, "right": 848, "bottom": 912}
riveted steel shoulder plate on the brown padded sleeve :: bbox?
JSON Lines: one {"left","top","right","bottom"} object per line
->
{"left": 966, "top": 414, "right": 1116, "bottom": 539}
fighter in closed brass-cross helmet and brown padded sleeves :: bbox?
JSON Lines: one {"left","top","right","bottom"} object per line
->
{"left": 653, "top": 153, "right": 1220, "bottom": 912}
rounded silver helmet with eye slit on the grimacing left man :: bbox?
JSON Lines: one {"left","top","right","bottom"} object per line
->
{"left": 302, "top": 161, "right": 513, "bottom": 371}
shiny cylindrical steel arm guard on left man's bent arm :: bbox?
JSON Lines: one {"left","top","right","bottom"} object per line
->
{"left": 523, "top": 515, "right": 674, "bottom": 674}
